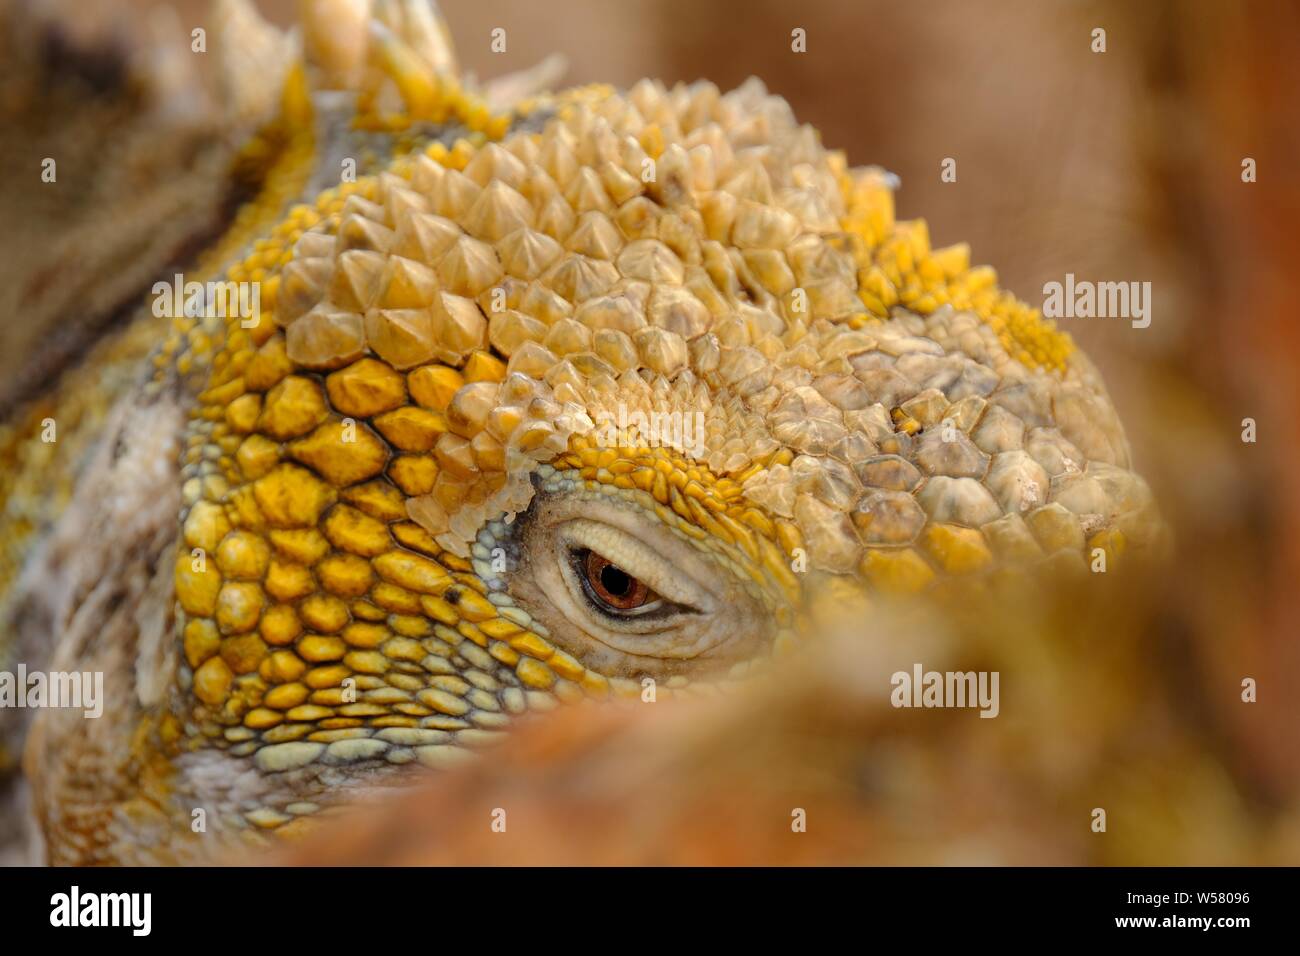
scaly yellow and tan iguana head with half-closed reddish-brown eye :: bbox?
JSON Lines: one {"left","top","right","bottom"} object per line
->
{"left": 0, "top": 5, "right": 1158, "bottom": 862}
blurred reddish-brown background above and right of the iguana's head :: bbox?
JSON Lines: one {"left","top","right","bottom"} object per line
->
{"left": 5, "top": 0, "right": 1300, "bottom": 862}
